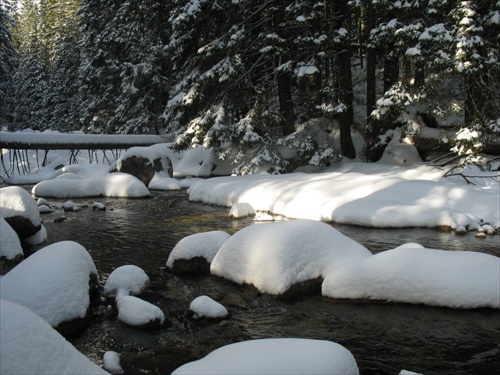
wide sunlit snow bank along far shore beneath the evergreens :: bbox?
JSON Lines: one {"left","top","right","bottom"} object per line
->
{"left": 188, "top": 162, "right": 500, "bottom": 229}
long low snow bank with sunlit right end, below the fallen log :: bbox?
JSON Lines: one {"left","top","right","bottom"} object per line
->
{"left": 31, "top": 173, "right": 150, "bottom": 199}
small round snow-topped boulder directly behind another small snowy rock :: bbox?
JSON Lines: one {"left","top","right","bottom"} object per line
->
{"left": 103, "top": 264, "right": 149, "bottom": 297}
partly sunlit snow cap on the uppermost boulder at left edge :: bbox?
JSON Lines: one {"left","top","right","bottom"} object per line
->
{"left": 0, "top": 186, "right": 42, "bottom": 226}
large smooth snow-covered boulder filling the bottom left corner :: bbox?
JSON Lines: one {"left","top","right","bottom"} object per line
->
{"left": 0, "top": 300, "right": 107, "bottom": 375}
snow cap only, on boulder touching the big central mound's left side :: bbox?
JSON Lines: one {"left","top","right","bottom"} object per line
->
{"left": 167, "top": 230, "right": 231, "bottom": 268}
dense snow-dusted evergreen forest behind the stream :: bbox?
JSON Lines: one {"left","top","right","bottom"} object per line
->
{"left": 0, "top": 0, "right": 500, "bottom": 174}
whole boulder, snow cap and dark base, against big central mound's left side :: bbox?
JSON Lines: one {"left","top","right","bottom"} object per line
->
{"left": 167, "top": 230, "right": 231, "bottom": 275}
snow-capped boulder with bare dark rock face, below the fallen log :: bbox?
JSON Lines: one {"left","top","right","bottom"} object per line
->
{"left": 113, "top": 147, "right": 173, "bottom": 186}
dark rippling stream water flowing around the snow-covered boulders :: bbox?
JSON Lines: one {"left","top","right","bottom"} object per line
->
{"left": 32, "top": 192, "right": 500, "bottom": 375}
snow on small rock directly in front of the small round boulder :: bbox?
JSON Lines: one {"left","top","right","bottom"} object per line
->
{"left": 116, "top": 295, "right": 165, "bottom": 326}
